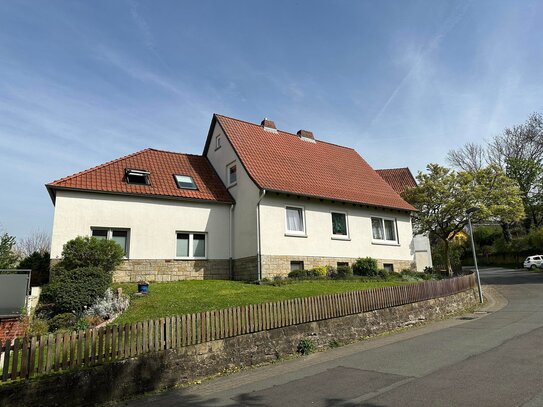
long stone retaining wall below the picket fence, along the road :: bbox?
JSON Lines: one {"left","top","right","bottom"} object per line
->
{"left": 0, "top": 290, "right": 477, "bottom": 407}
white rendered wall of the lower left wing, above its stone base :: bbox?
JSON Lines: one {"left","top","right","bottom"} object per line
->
{"left": 51, "top": 190, "right": 230, "bottom": 259}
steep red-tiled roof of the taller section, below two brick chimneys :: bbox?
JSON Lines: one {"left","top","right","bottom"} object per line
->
{"left": 208, "top": 115, "right": 416, "bottom": 211}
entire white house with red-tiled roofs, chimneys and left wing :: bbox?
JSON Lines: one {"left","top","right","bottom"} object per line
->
{"left": 47, "top": 115, "right": 415, "bottom": 281}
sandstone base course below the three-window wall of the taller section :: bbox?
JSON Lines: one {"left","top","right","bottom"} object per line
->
{"left": 262, "top": 255, "right": 415, "bottom": 278}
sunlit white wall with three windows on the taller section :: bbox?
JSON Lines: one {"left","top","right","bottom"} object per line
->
{"left": 260, "top": 193, "right": 414, "bottom": 261}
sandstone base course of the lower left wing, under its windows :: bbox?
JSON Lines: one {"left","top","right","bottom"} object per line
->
{"left": 113, "top": 259, "right": 230, "bottom": 283}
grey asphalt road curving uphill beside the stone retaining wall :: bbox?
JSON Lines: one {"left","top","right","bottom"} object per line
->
{"left": 121, "top": 269, "right": 543, "bottom": 407}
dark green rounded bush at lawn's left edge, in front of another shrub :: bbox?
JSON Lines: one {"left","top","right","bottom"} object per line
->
{"left": 42, "top": 267, "right": 112, "bottom": 314}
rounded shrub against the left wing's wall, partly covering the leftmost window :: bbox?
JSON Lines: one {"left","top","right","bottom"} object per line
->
{"left": 60, "top": 236, "right": 124, "bottom": 272}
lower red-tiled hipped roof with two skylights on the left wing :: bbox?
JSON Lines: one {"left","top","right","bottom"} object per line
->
{"left": 46, "top": 148, "right": 234, "bottom": 203}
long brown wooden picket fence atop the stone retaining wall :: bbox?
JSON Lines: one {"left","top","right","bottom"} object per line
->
{"left": 0, "top": 275, "right": 475, "bottom": 382}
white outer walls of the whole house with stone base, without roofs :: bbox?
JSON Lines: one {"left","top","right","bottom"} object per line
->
{"left": 47, "top": 121, "right": 420, "bottom": 280}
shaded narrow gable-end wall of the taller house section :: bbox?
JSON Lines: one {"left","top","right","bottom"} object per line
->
{"left": 207, "top": 124, "right": 260, "bottom": 259}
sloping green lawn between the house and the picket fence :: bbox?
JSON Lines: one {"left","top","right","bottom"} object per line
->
{"left": 115, "top": 279, "right": 412, "bottom": 323}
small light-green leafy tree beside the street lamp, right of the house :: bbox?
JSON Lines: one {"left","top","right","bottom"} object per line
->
{"left": 403, "top": 164, "right": 524, "bottom": 274}
